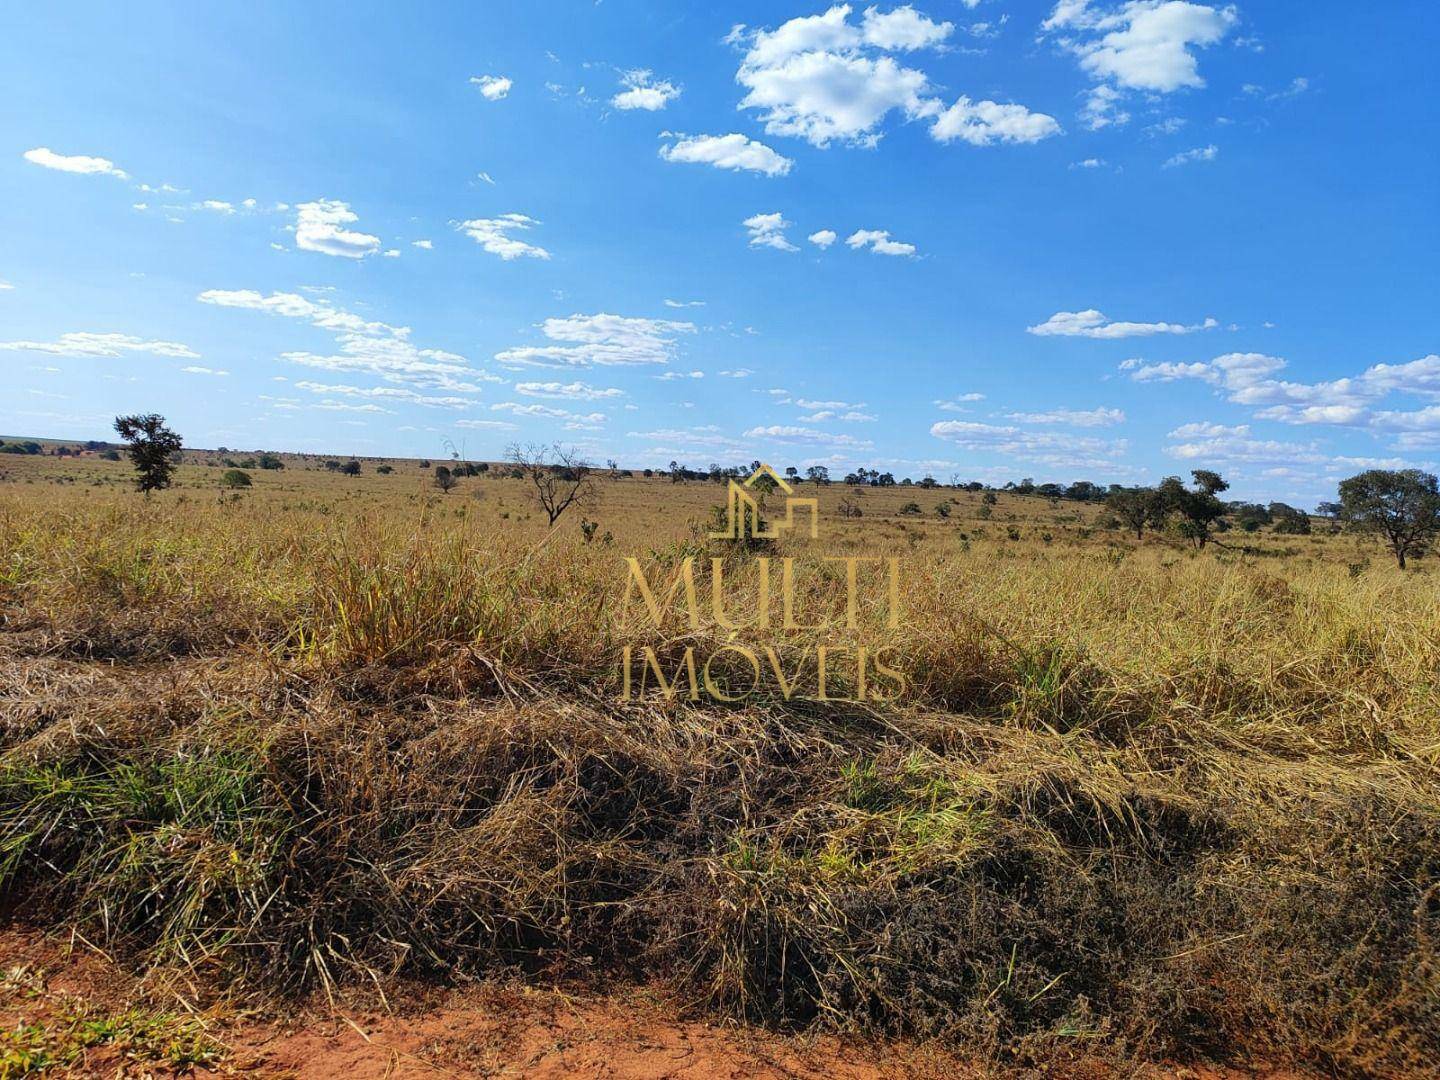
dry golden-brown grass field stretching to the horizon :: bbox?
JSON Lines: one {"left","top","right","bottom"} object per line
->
{"left": 0, "top": 452, "right": 1440, "bottom": 1076}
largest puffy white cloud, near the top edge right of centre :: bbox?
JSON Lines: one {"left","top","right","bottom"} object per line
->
{"left": 727, "top": 4, "right": 1060, "bottom": 147}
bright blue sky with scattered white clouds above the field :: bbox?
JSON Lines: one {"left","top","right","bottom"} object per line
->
{"left": 0, "top": 0, "right": 1440, "bottom": 503}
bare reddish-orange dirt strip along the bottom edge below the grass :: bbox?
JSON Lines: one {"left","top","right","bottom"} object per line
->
{"left": 0, "top": 927, "right": 1302, "bottom": 1080}
